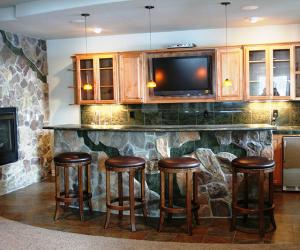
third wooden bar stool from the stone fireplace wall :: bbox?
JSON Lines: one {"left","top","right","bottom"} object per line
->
{"left": 158, "top": 157, "right": 200, "bottom": 235}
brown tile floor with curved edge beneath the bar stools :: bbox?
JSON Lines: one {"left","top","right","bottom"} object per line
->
{"left": 0, "top": 181, "right": 300, "bottom": 244}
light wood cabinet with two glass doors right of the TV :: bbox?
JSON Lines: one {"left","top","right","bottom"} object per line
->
{"left": 245, "top": 45, "right": 294, "bottom": 100}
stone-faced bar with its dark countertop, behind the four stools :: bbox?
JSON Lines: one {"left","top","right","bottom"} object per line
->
{"left": 44, "top": 124, "right": 274, "bottom": 217}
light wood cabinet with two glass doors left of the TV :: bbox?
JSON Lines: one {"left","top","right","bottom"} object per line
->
{"left": 74, "top": 54, "right": 118, "bottom": 104}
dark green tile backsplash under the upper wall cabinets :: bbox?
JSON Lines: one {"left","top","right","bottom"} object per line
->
{"left": 81, "top": 101, "right": 300, "bottom": 126}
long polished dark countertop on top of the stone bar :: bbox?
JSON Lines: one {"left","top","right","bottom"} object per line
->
{"left": 43, "top": 124, "right": 276, "bottom": 132}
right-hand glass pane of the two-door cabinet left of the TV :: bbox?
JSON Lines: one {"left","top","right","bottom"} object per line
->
{"left": 99, "top": 58, "right": 114, "bottom": 100}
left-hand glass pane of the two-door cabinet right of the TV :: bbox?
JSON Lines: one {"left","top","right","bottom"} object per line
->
{"left": 248, "top": 50, "right": 268, "bottom": 97}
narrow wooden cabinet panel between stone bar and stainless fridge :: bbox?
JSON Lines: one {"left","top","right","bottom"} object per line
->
{"left": 272, "top": 135, "right": 283, "bottom": 186}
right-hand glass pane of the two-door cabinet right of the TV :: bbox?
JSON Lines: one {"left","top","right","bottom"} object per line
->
{"left": 272, "top": 49, "right": 291, "bottom": 98}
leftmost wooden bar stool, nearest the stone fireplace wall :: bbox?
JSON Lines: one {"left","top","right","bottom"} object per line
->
{"left": 54, "top": 152, "right": 92, "bottom": 220}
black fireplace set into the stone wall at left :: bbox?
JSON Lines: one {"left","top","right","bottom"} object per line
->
{"left": 0, "top": 108, "right": 18, "bottom": 165}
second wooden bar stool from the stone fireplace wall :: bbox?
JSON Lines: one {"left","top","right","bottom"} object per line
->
{"left": 104, "top": 156, "right": 147, "bottom": 232}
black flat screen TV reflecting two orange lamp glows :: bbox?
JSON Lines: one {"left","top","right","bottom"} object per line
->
{"left": 152, "top": 55, "right": 213, "bottom": 96}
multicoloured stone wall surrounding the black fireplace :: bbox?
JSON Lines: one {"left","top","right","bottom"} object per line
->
{"left": 0, "top": 30, "right": 51, "bottom": 194}
